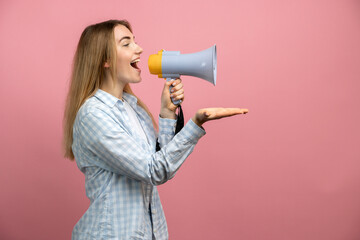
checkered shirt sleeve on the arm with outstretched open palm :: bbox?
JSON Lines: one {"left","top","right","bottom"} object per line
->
{"left": 78, "top": 109, "right": 205, "bottom": 185}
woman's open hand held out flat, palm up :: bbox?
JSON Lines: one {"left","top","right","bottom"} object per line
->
{"left": 192, "top": 108, "right": 249, "bottom": 127}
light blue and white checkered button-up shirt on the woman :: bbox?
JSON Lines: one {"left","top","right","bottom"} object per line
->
{"left": 72, "top": 90, "right": 205, "bottom": 240}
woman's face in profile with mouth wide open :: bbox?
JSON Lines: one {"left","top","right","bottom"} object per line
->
{"left": 114, "top": 25, "right": 143, "bottom": 85}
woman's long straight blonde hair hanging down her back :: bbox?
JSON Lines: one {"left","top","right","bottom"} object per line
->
{"left": 63, "top": 20, "right": 158, "bottom": 160}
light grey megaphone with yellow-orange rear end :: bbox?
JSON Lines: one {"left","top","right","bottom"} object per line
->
{"left": 148, "top": 45, "right": 217, "bottom": 105}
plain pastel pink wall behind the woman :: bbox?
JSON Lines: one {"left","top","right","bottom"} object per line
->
{"left": 0, "top": 0, "right": 360, "bottom": 240}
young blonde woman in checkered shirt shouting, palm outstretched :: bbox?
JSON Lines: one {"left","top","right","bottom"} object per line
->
{"left": 64, "top": 20, "right": 247, "bottom": 240}
